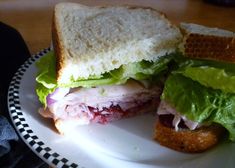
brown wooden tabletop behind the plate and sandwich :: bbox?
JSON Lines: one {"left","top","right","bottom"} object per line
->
{"left": 0, "top": 0, "right": 235, "bottom": 54}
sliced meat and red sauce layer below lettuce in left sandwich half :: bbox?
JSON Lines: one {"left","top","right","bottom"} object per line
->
{"left": 39, "top": 80, "right": 161, "bottom": 124}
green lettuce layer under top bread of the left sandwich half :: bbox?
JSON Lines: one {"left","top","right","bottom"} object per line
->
{"left": 36, "top": 51, "right": 174, "bottom": 106}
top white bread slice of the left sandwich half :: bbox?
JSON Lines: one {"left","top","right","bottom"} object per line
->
{"left": 52, "top": 3, "right": 182, "bottom": 83}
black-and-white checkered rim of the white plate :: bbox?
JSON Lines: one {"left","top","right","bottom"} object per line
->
{"left": 8, "top": 48, "right": 80, "bottom": 168}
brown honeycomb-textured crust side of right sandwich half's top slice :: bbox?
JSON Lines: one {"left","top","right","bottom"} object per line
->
{"left": 184, "top": 34, "right": 235, "bottom": 63}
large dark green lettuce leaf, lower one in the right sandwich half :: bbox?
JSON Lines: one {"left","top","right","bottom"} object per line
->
{"left": 161, "top": 74, "right": 235, "bottom": 141}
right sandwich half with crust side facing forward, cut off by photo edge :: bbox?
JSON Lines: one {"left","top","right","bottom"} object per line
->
{"left": 154, "top": 23, "right": 235, "bottom": 153}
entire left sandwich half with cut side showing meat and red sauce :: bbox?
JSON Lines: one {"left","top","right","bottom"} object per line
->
{"left": 36, "top": 3, "right": 182, "bottom": 134}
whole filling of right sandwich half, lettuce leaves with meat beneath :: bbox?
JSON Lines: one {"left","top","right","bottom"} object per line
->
{"left": 157, "top": 57, "right": 235, "bottom": 141}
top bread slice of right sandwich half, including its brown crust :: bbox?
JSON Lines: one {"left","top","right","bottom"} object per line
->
{"left": 179, "top": 23, "right": 235, "bottom": 62}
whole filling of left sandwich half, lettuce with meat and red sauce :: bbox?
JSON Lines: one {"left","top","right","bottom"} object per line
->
{"left": 36, "top": 52, "right": 174, "bottom": 127}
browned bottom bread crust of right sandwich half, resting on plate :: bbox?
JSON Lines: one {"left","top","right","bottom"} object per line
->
{"left": 154, "top": 121, "right": 225, "bottom": 153}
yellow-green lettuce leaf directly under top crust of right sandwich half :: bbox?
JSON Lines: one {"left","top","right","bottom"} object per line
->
{"left": 170, "top": 54, "right": 235, "bottom": 93}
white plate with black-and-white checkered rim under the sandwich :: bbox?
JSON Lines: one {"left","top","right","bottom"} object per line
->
{"left": 8, "top": 49, "right": 235, "bottom": 168}
